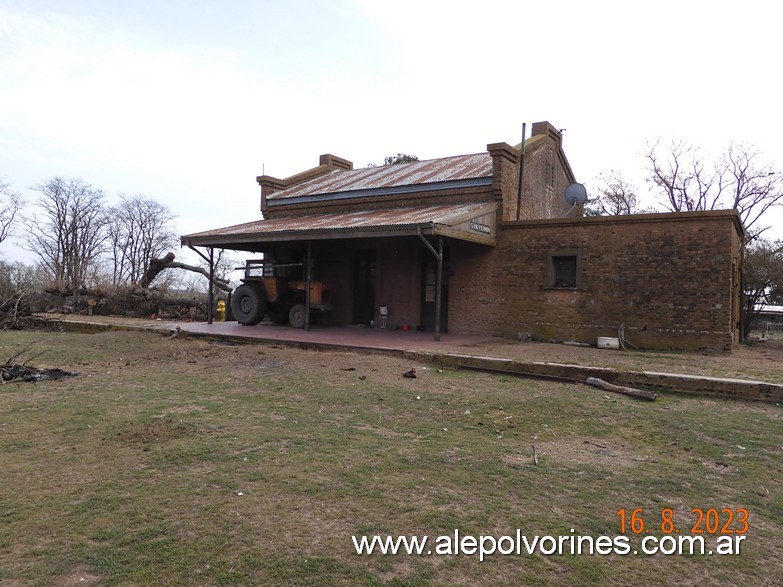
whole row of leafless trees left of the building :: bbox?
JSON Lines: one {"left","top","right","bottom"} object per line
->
{"left": 0, "top": 177, "right": 177, "bottom": 291}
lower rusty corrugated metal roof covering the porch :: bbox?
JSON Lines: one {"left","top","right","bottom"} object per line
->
{"left": 182, "top": 202, "right": 496, "bottom": 241}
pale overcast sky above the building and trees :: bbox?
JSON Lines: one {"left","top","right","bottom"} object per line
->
{"left": 0, "top": 0, "right": 783, "bottom": 260}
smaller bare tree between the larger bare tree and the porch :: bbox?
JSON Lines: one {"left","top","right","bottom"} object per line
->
{"left": 107, "top": 195, "right": 176, "bottom": 285}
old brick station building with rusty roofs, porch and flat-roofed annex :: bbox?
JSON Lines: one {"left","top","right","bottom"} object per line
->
{"left": 182, "top": 122, "right": 743, "bottom": 350}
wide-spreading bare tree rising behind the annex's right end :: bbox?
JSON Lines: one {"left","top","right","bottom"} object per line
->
{"left": 646, "top": 141, "right": 783, "bottom": 238}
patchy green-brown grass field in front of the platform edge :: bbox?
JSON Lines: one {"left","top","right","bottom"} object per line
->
{"left": 0, "top": 332, "right": 783, "bottom": 586}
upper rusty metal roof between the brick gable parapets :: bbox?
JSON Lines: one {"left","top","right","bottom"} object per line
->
{"left": 267, "top": 153, "right": 492, "bottom": 200}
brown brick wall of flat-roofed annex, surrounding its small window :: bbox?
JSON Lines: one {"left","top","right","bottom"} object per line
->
{"left": 449, "top": 212, "right": 739, "bottom": 350}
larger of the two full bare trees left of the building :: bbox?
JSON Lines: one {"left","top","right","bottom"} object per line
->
{"left": 25, "top": 177, "right": 106, "bottom": 291}
